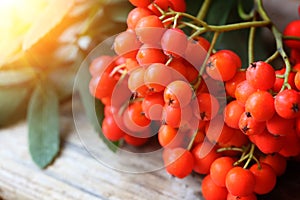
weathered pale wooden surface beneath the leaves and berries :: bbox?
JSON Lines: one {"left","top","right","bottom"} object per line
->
{"left": 0, "top": 96, "right": 201, "bottom": 200}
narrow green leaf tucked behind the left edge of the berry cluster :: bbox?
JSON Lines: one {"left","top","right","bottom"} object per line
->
{"left": 75, "top": 62, "right": 119, "bottom": 152}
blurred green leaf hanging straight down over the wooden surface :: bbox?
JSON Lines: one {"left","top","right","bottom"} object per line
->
{"left": 27, "top": 84, "right": 60, "bottom": 168}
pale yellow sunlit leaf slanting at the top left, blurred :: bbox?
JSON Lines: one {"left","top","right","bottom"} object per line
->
{"left": 22, "top": 0, "right": 74, "bottom": 50}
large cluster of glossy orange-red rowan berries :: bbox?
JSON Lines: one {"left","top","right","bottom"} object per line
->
{"left": 89, "top": 0, "right": 300, "bottom": 200}
